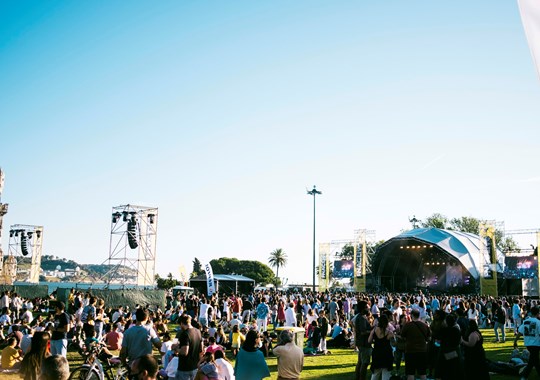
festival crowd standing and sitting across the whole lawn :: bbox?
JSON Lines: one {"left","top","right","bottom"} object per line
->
{"left": 0, "top": 291, "right": 540, "bottom": 380}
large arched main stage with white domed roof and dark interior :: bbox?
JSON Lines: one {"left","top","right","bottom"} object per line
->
{"left": 375, "top": 228, "right": 504, "bottom": 290}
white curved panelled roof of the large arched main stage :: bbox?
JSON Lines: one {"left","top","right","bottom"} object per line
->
{"left": 379, "top": 228, "right": 504, "bottom": 279}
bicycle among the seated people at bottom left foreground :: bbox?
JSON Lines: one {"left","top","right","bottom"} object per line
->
{"left": 69, "top": 343, "right": 129, "bottom": 380}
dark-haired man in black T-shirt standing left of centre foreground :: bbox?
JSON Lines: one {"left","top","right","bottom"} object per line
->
{"left": 175, "top": 314, "right": 203, "bottom": 380}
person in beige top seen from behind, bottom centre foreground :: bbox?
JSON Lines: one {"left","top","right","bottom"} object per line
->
{"left": 272, "top": 330, "right": 304, "bottom": 380}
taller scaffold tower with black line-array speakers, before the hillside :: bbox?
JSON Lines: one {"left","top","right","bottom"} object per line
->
{"left": 103, "top": 204, "right": 158, "bottom": 286}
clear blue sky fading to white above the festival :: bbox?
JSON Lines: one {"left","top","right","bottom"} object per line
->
{"left": 0, "top": 0, "right": 540, "bottom": 283}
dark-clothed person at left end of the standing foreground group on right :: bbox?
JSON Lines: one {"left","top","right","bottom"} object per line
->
{"left": 354, "top": 301, "right": 372, "bottom": 380}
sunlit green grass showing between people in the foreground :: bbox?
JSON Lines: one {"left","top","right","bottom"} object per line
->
{"left": 0, "top": 330, "right": 540, "bottom": 380}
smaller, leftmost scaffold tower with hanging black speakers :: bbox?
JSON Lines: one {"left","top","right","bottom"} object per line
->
{"left": 2, "top": 224, "right": 43, "bottom": 285}
